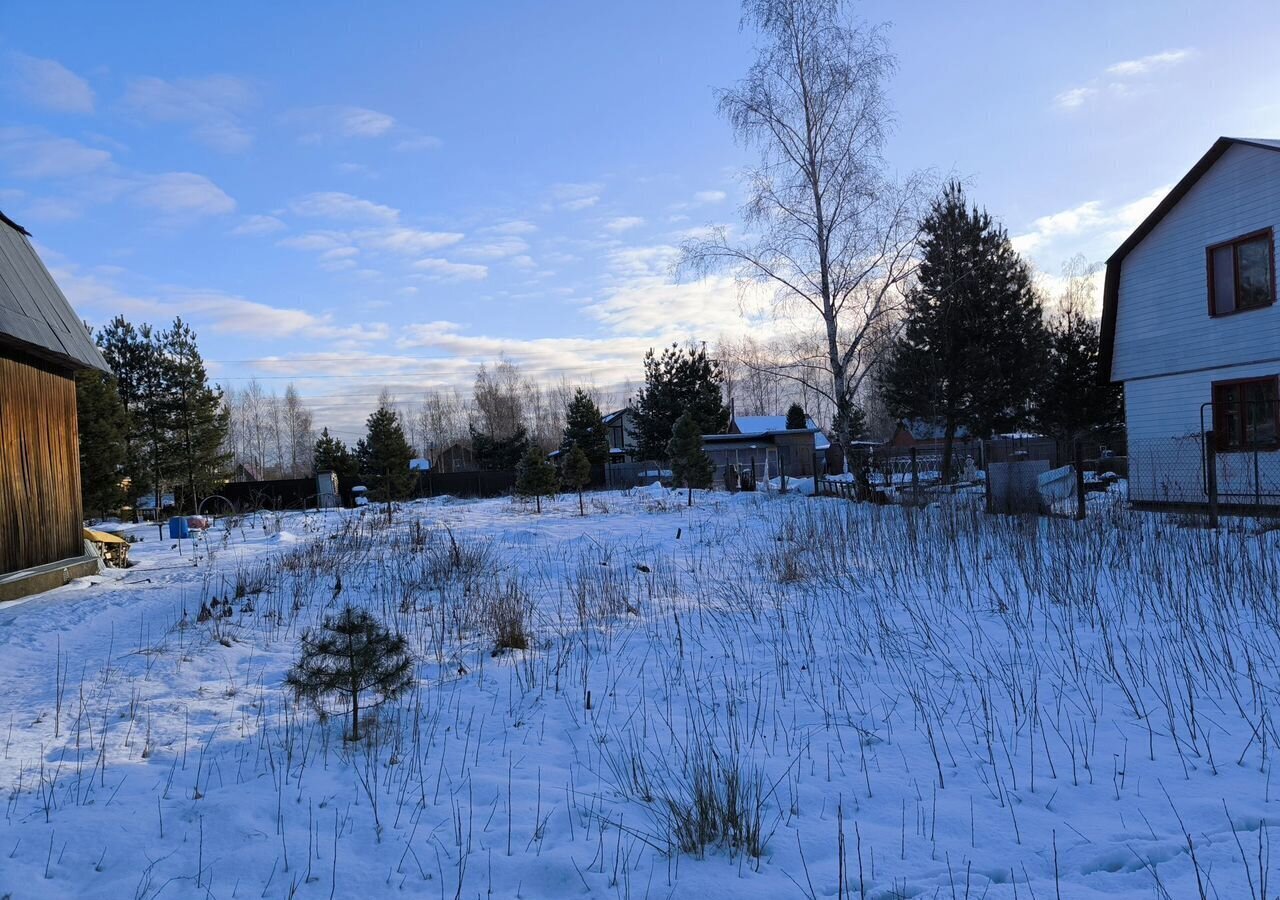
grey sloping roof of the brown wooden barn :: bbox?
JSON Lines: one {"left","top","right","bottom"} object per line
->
{"left": 0, "top": 213, "right": 110, "bottom": 371}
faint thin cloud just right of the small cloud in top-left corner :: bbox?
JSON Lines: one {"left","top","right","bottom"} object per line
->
{"left": 124, "top": 76, "right": 255, "bottom": 152}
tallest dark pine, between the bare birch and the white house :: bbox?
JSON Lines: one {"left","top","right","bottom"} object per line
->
{"left": 881, "top": 183, "right": 1047, "bottom": 479}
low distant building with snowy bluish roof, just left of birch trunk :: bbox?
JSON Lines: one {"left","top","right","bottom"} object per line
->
{"left": 703, "top": 416, "right": 831, "bottom": 486}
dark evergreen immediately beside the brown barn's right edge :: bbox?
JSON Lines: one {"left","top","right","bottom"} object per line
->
{"left": 76, "top": 370, "right": 128, "bottom": 517}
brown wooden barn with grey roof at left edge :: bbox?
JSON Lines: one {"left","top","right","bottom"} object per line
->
{"left": 0, "top": 213, "right": 108, "bottom": 600}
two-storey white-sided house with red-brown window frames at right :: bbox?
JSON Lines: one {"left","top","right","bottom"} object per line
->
{"left": 1102, "top": 137, "right": 1280, "bottom": 507}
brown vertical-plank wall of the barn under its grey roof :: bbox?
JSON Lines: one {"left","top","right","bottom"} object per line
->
{"left": 0, "top": 350, "right": 84, "bottom": 575}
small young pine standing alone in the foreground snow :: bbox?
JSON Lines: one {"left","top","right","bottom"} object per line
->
{"left": 285, "top": 606, "right": 413, "bottom": 741}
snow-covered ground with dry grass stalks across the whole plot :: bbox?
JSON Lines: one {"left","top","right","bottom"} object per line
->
{"left": 0, "top": 489, "right": 1280, "bottom": 900}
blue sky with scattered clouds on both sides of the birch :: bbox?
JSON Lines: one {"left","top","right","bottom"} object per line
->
{"left": 0, "top": 0, "right": 1280, "bottom": 431}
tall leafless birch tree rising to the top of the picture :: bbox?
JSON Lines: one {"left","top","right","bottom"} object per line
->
{"left": 681, "top": 0, "right": 925, "bottom": 460}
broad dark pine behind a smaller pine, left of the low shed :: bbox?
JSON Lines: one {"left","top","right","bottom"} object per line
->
{"left": 632, "top": 344, "right": 728, "bottom": 460}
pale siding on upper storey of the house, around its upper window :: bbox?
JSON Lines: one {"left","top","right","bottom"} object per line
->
{"left": 1111, "top": 145, "right": 1280, "bottom": 381}
